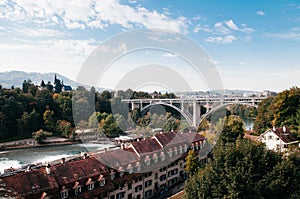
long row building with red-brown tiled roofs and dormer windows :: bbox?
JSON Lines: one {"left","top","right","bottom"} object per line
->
{"left": 0, "top": 132, "right": 210, "bottom": 199}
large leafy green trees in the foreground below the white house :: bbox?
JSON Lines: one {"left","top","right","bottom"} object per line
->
{"left": 185, "top": 113, "right": 300, "bottom": 199}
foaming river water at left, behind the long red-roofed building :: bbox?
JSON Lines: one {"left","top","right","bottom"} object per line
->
{"left": 0, "top": 143, "right": 114, "bottom": 173}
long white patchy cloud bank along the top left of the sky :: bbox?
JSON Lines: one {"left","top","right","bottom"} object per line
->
{"left": 0, "top": 0, "right": 188, "bottom": 32}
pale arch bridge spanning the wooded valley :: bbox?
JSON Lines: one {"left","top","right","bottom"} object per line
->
{"left": 122, "top": 97, "right": 266, "bottom": 128}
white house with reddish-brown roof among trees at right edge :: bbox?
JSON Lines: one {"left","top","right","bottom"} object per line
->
{"left": 259, "top": 126, "right": 298, "bottom": 152}
